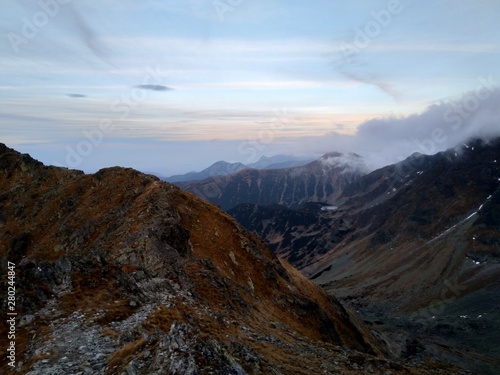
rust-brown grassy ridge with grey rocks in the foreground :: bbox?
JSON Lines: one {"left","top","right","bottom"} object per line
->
{"left": 0, "top": 145, "right": 424, "bottom": 374}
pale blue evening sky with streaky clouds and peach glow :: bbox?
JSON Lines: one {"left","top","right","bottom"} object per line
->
{"left": 0, "top": 0, "right": 500, "bottom": 176}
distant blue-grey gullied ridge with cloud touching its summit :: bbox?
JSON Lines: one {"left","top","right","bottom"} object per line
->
{"left": 182, "top": 152, "right": 366, "bottom": 210}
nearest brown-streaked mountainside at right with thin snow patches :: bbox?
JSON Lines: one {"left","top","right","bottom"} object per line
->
{"left": 310, "top": 139, "right": 500, "bottom": 374}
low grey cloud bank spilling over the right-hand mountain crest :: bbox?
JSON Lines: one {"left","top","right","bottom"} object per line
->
{"left": 287, "top": 86, "right": 500, "bottom": 169}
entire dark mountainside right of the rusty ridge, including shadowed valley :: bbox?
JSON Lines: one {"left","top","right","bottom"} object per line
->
{"left": 229, "top": 139, "right": 500, "bottom": 374}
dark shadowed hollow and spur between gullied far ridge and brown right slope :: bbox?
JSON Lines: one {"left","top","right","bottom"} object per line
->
{"left": 228, "top": 154, "right": 440, "bottom": 269}
